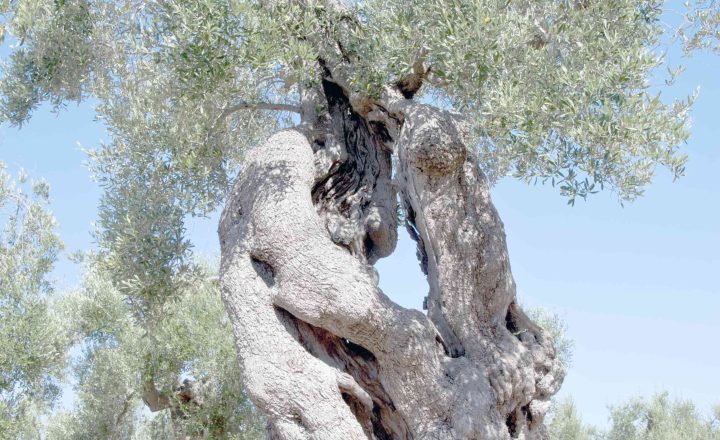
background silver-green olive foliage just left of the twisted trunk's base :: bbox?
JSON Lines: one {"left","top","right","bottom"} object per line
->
{"left": 48, "top": 261, "right": 264, "bottom": 440}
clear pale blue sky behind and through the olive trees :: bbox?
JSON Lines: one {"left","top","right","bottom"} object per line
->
{"left": 0, "top": 6, "right": 720, "bottom": 426}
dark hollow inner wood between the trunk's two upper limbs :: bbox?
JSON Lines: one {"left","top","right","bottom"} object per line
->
{"left": 312, "top": 72, "right": 397, "bottom": 264}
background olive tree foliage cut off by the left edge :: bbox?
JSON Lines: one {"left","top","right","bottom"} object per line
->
{"left": 0, "top": 162, "right": 67, "bottom": 439}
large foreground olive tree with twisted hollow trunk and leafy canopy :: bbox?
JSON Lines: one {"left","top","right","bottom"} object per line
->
{"left": 0, "top": 0, "right": 712, "bottom": 439}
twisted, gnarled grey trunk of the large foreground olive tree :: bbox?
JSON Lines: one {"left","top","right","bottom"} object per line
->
{"left": 219, "top": 72, "right": 563, "bottom": 439}
